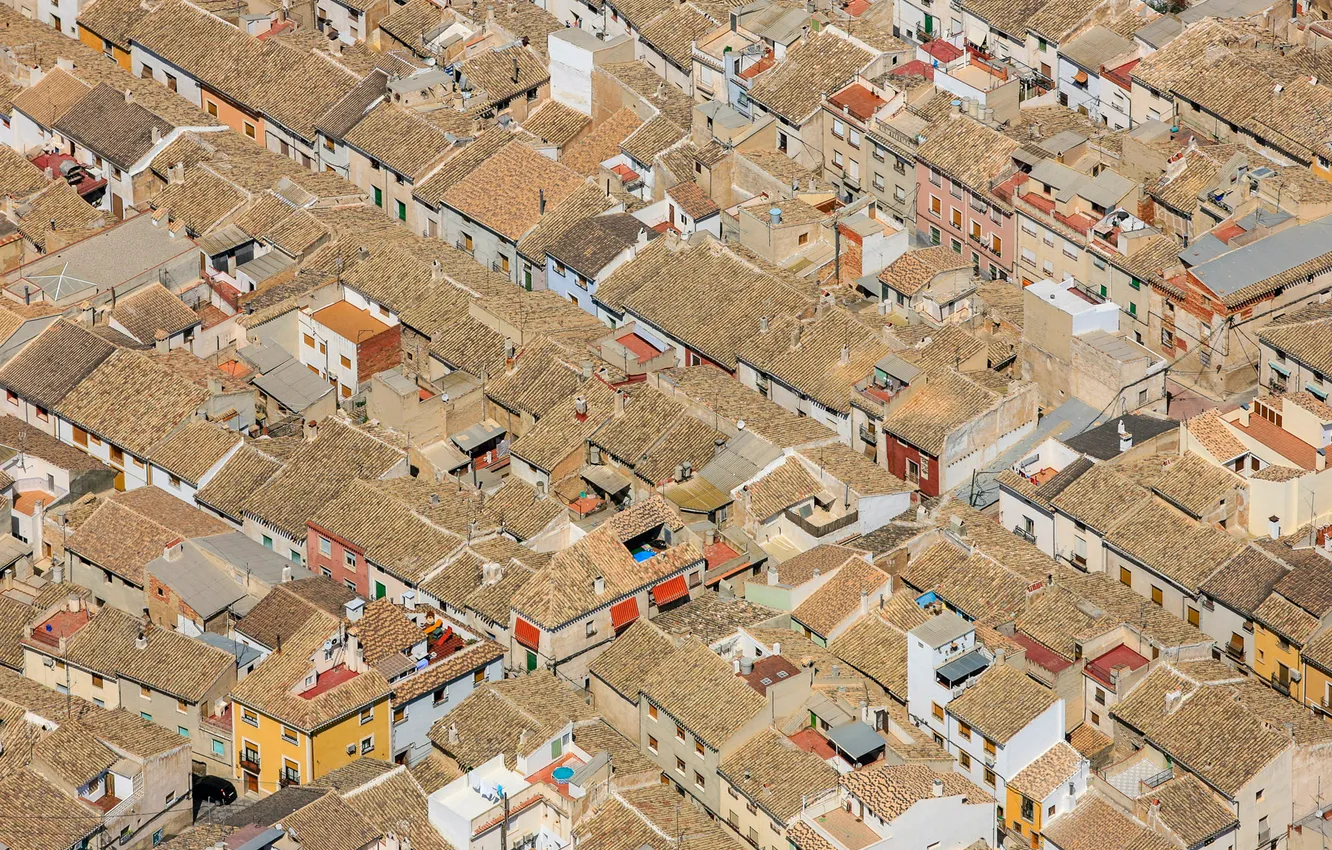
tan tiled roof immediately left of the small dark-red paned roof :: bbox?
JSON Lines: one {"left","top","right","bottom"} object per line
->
{"left": 642, "top": 638, "right": 766, "bottom": 750}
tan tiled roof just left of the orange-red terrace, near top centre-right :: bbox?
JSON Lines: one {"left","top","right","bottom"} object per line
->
{"left": 749, "top": 32, "right": 874, "bottom": 124}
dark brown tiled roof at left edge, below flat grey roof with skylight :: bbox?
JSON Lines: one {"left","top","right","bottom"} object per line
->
{"left": 0, "top": 320, "right": 116, "bottom": 410}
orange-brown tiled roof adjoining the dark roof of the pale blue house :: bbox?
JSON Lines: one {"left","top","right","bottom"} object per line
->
{"left": 441, "top": 143, "right": 582, "bottom": 241}
